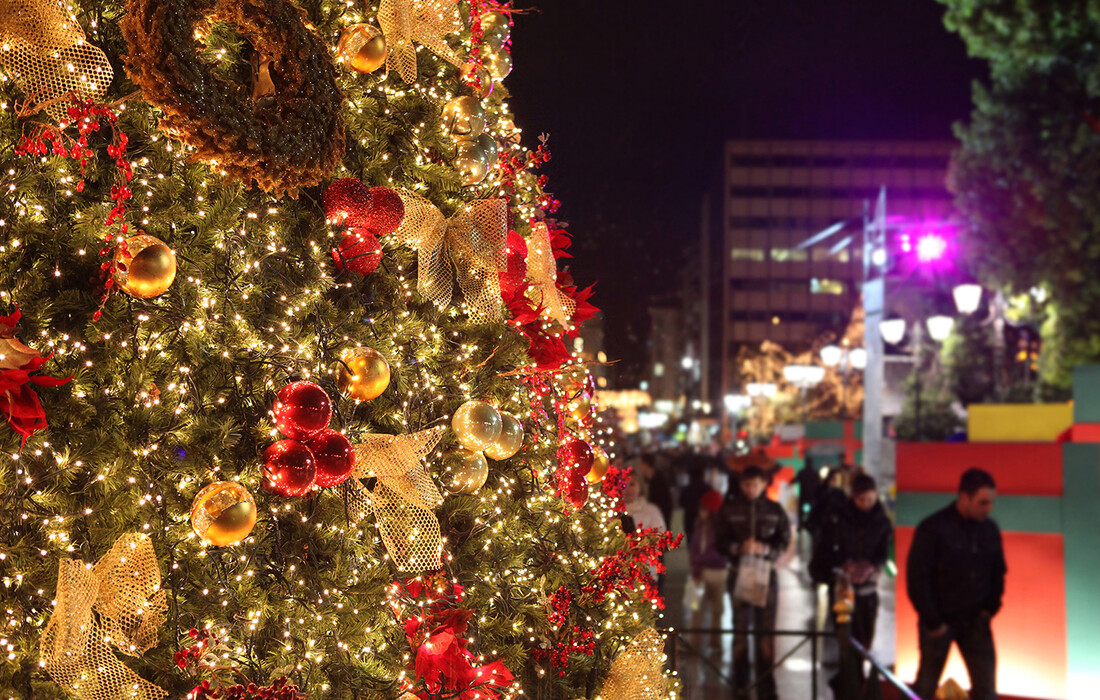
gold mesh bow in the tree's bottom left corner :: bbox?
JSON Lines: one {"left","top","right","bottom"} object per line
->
{"left": 41, "top": 533, "right": 168, "bottom": 700}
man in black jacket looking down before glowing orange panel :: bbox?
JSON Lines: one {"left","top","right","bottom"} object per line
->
{"left": 906, "top": 469, "right": 1008, "bottom": 700}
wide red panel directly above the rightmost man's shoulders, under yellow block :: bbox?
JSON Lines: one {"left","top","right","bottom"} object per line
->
{"left": 897, "top": 442, "right": 1062, "bottom": 495}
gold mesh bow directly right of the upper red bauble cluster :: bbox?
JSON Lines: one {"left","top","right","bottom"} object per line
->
{"left": 394, "top": 189, "right": 508, "bottom": 321}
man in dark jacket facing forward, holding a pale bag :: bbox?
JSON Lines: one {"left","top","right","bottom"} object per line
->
{"left": 718, "top": 467, "right": 791, "bottom": 700}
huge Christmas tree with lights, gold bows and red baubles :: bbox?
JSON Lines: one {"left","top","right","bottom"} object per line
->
{"left": 0, "top": 0, "right": 675, "bottom": 700}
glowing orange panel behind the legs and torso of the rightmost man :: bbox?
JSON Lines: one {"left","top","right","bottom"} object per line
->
{"left": 897, "top": 527, "right": 1067, "bottom": 700}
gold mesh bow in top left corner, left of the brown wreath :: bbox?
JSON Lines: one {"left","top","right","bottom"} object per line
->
{"left": 0, "top": 0, "right": 114, "bottom": 120}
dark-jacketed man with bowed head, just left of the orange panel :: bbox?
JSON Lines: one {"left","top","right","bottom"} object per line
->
{"left": 815, "top": 474, "right": 893, "bottom": 649}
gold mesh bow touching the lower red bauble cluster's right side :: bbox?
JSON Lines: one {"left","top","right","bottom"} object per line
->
{"left": 344, "top": 426, "right": 447, "bottom": 572}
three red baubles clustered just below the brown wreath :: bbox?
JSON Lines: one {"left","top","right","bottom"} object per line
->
{"left": 321, "top": 177, "right": 405, "bottom": 275}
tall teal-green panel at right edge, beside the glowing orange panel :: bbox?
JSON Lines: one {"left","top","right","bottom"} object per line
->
{"left": 1062, "top": 442, "right": 1100, "bottom": 698}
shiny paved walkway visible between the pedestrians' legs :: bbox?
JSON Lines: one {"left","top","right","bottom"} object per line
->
{"left": 664, "top": 511, "right": 894, "bottom": 700}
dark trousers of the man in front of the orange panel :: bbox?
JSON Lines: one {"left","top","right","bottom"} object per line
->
{"left": 913, "top": 615, "right": 997, "bottom": 700}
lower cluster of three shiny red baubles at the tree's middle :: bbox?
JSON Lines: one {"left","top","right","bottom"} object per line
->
{"left": 264, "top": 382, "right": 355, "bottom": 497}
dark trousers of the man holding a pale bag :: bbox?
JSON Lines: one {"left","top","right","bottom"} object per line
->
{"left": 729, "top": 569, "right": 779, "bottom": 700}
